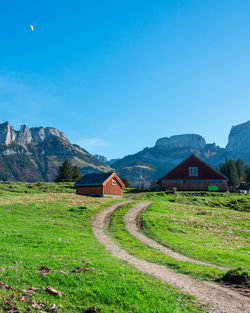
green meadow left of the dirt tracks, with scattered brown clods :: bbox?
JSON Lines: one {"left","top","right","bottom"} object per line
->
{"left": 0, "top": 183, "right": 203, "bottom": 313}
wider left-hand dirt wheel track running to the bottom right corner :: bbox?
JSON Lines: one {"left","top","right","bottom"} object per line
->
{"left": 92, "top": 201, "right": 250, "bottom": 313}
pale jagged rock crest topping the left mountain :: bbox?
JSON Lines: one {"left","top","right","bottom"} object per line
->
{"left": 0, "top": 122, "right": 69, "bottom": 145}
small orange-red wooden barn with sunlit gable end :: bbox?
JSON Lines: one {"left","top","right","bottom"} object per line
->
{"left": 75, "top": 172, "right": 125, "bottom": 196}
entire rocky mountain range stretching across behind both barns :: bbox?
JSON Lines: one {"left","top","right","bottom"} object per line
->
{"left": 0, "top": 121, "right": 250, "bottom": 185}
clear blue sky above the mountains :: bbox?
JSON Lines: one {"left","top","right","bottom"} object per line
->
{"left": 0, "top": 0, "right": 250, "bottom": 158}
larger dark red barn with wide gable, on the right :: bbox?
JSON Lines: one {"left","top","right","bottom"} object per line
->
{"left": 158, "top": 155, "right": 228, "bottom": 191}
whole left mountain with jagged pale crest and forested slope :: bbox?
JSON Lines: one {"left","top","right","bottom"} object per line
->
{"left": 0, "top": 122, "right": 111, "bottom": 181}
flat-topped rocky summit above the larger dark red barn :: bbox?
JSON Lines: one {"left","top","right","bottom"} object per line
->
{"left": 155, "top": 134, "right": 206, "bottom": 149}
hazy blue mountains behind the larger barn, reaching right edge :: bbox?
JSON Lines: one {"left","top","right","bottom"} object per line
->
{"left": 112, "top": 121, "right": 250, "bottom": 185}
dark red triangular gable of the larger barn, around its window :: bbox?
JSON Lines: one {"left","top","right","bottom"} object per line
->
{"left": 160, "top": 154, "right": 228, "bottom": 180}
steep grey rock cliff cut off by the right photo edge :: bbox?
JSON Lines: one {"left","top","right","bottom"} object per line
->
{"left": 226, "top": 121, "right": 250, "bottom": 153}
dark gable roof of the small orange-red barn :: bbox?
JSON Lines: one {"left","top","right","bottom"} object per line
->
{"left": 75, "top": 172, "right": 125, "bottom": 188}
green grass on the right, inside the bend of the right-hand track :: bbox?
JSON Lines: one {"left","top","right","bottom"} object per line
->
{"left": 142, "top": 196, "right": 250, "bottom": 269}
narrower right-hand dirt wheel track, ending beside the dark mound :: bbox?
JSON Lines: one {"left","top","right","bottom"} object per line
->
{"left": 124, "top": 201, "right": 229, "bottom": 270}
